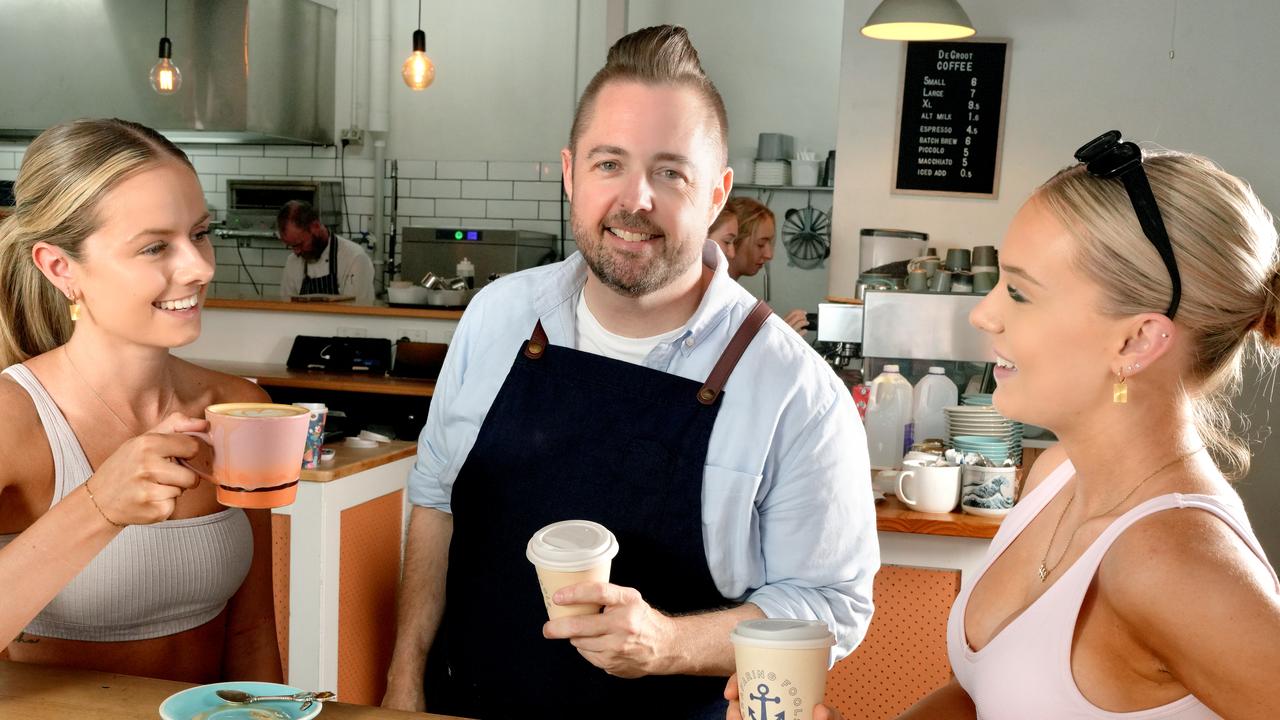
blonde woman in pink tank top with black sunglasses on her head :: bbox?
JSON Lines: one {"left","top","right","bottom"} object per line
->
{"left": 730, "top": 133, "right": 1280, "bottom": 720}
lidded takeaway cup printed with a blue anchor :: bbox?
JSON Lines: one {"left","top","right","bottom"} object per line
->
{"left": 728, "top": 618, "right": 836, "bottom": 717}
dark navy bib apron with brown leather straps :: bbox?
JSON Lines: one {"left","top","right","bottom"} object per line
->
{"left": 426, "top": 302, "right": 771, "bottom": 720}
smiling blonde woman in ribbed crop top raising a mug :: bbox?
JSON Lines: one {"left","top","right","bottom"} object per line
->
{"left": 0, "top": 120, "right": 280, "bottom": 682}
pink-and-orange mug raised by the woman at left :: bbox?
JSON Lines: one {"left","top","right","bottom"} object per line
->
{"left": 182, "top": 402, "right": 311, "bottom": 507}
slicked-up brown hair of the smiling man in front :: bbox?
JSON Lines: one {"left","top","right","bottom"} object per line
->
{"left": 568, "top": 26, "right": 728, "bottom": 167}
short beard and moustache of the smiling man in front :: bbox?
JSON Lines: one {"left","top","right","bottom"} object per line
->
{"left": 570, "top": 210, "right": 701, "bottom": 297}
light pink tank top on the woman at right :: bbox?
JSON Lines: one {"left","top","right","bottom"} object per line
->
{"left": 947, "top": 461, "right": 1280, "bottom": 720}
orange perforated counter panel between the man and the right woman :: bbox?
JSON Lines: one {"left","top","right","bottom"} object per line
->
{"left": 827, "top": 565, "right": 960, "bottom": 720}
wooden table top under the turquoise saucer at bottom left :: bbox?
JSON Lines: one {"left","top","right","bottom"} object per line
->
{"left": 0, "top": 661, "right": 471, "bottom": 720}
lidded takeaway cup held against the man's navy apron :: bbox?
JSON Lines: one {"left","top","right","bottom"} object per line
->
{"left": 525, "top": 520, "right": 618, "bottom": 620}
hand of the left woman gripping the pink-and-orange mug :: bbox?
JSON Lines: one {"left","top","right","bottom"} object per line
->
{"left": 84, "top": 413, "right": 209, "bottom": 525}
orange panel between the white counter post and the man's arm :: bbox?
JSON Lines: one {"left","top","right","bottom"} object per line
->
{"left": 338, "top": 491, "right": 402, "bottom": 705}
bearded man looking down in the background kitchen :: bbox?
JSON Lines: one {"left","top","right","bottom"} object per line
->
{"left": 275, "top": 200, "right": 374, "bottom": 305}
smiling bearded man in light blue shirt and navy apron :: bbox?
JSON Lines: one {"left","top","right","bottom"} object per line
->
{"left": 383, "top": 26, "right": 879, "bottom": 719}
